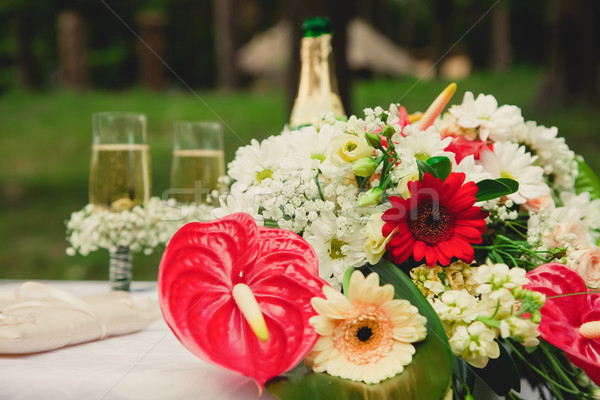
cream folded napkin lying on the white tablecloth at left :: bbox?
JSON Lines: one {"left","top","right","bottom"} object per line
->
{"left": 0, "top": 282, "right": 160, "bottom": 354}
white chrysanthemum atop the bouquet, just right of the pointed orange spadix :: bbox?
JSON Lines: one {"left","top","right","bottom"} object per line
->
{"left": 448, "top": 92, "right": 523, "bottom": 142}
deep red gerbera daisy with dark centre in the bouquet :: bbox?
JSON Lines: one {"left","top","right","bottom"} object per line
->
{"left": 382, "top": 172, "right": 487, "bottom": 267}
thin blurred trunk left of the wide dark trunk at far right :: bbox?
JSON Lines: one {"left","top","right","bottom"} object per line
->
{"left": 490, "top": 1, "right": 512, "bottom": 72}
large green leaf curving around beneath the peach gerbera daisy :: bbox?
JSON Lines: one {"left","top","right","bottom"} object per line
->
{"left": 266, "top": 260, "right": 454, "bottom": 400}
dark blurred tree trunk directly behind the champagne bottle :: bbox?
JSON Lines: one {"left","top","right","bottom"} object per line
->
{"left": 284, "top": 0, "right": 355, "bottom": 115}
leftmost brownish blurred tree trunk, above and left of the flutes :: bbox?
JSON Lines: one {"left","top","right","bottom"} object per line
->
{"left": 58, "top": 10, "right": 89, "bottom": 90}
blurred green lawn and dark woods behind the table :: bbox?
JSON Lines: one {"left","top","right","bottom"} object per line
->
{"left": 0, "top": 0, "right": 600, "bottom": 279}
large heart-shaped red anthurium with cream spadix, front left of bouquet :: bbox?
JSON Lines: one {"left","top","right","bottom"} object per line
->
{"left": 158, "top": 213, "right": 326, "bottom": 388}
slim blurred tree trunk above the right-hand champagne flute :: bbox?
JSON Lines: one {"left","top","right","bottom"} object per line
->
{"left": 213, "top": 0, "right": 239, "bottom": 90}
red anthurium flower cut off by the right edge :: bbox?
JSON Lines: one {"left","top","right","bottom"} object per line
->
{"left": 525, "top": 264, "right": 600, "bottom": 385}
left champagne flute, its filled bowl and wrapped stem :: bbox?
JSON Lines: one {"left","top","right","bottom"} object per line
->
{"left": 90, "top": 112, "right": 150, "bottom": 291}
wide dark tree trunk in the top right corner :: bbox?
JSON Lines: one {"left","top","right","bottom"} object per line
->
{"left": 535, "top": 0, "right": 600, "bottom": 111}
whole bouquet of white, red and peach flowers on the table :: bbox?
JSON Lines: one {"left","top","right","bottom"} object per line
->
{"left": 159, "top": 84, "right": 600, "bottom": 400}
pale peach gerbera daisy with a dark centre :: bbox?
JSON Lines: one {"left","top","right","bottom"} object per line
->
{"left": 306, "top": 271, "right": 427, "bottom": 383}
